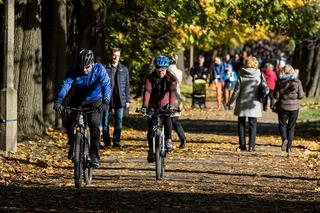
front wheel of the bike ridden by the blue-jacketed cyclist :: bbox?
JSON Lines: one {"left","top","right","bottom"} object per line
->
{"left": 73, "top": 133, "right": 83, "bottom": 188}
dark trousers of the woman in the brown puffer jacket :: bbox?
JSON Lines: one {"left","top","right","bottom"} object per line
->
{"left": 278, "top": 110, "right": 299, "bottom": 148}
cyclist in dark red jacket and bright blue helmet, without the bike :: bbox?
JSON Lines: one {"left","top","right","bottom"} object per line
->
{"left": 141, "top": 55, "right": 177, "bottom": 163}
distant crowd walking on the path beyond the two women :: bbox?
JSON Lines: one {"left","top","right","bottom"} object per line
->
{"left": 189, "top": 41, "right": 290, "bottom": 111}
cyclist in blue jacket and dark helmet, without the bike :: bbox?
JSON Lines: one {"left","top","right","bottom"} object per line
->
{"left": 53, "top": 49, "right": 111, "bottom": 166}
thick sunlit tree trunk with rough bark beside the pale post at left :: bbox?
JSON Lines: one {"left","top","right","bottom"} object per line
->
{"left": 15, "top": 0, "right": 44, "bottom": 135}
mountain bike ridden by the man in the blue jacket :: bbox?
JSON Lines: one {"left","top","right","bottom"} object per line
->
{"left": 64, "top": 107, "right": 97, "bottom": 188}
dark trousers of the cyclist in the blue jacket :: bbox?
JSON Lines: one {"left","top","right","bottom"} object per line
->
{"left": 66, "top": 100, "right": 101, "bottom": 156}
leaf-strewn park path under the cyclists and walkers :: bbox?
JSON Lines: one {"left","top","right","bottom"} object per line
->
{"left": 0, "top": 86, "right": 320, "bottom": 212}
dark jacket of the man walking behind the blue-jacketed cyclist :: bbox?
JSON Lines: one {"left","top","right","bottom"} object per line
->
{"left": 106, "top": 63, "right": 130, "bottom": 107}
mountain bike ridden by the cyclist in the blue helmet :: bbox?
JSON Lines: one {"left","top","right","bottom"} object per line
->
{"left": 136, "top": 109, "right": 179, "bottom": 180}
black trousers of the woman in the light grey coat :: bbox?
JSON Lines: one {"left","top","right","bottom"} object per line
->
{"left": 238, "top": 117, "right": 257, "bottom": 148}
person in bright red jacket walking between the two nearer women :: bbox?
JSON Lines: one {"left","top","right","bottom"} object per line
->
{"left": 262, "top": 63, "right": 278, "bottom": 111}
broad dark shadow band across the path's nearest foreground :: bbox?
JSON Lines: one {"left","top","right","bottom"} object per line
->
{"left": 0, "top": 186, "right": 320, "bottom": 212}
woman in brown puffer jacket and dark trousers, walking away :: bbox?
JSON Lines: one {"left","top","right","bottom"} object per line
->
{"left": 274, "top": 64, "right": 304, "bottom": 154}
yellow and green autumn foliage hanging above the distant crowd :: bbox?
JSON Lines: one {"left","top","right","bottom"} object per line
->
{"left": 106, "top": 0, "right": 320, "bottom": 60}
